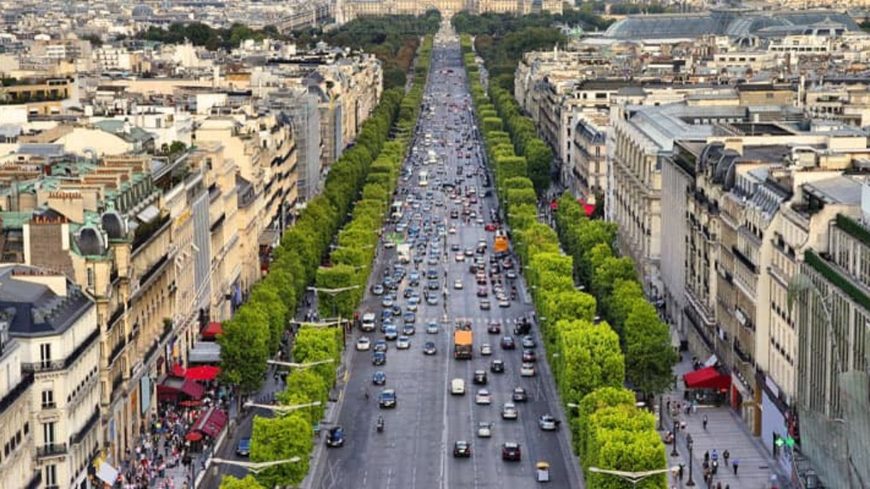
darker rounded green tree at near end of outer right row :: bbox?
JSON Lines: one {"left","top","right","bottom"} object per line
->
{"left": 624, "top": 299, "right": 677, "bottom": 396}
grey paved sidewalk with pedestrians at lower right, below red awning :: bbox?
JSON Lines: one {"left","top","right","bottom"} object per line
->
{"left": 662, "top": 352, "right": 789, "bottom": 489}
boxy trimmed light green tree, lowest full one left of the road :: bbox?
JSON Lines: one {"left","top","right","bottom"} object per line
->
{"left": 251, "top": 413, "right": 314, "bottom": 487}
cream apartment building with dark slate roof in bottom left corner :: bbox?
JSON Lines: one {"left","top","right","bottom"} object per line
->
{"left": 0, "top": 265, "right": 102, "bottom": 488}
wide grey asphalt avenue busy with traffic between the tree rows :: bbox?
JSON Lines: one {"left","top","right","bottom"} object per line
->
{"left": 311, "top": 27, "right": 581, "bottom": 489}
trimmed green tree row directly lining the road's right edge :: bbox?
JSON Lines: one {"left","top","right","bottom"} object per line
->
{"left": 460, "top": 35, "right": 669, "bottom": 488}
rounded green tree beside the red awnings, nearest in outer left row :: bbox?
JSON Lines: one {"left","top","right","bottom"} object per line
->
{"left": 218, "top": 305, "right": 270, "bottom": 394}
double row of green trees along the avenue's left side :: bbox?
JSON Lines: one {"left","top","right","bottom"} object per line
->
{"left": 219, "top": 36, "right": 432, "bottom": 489}
